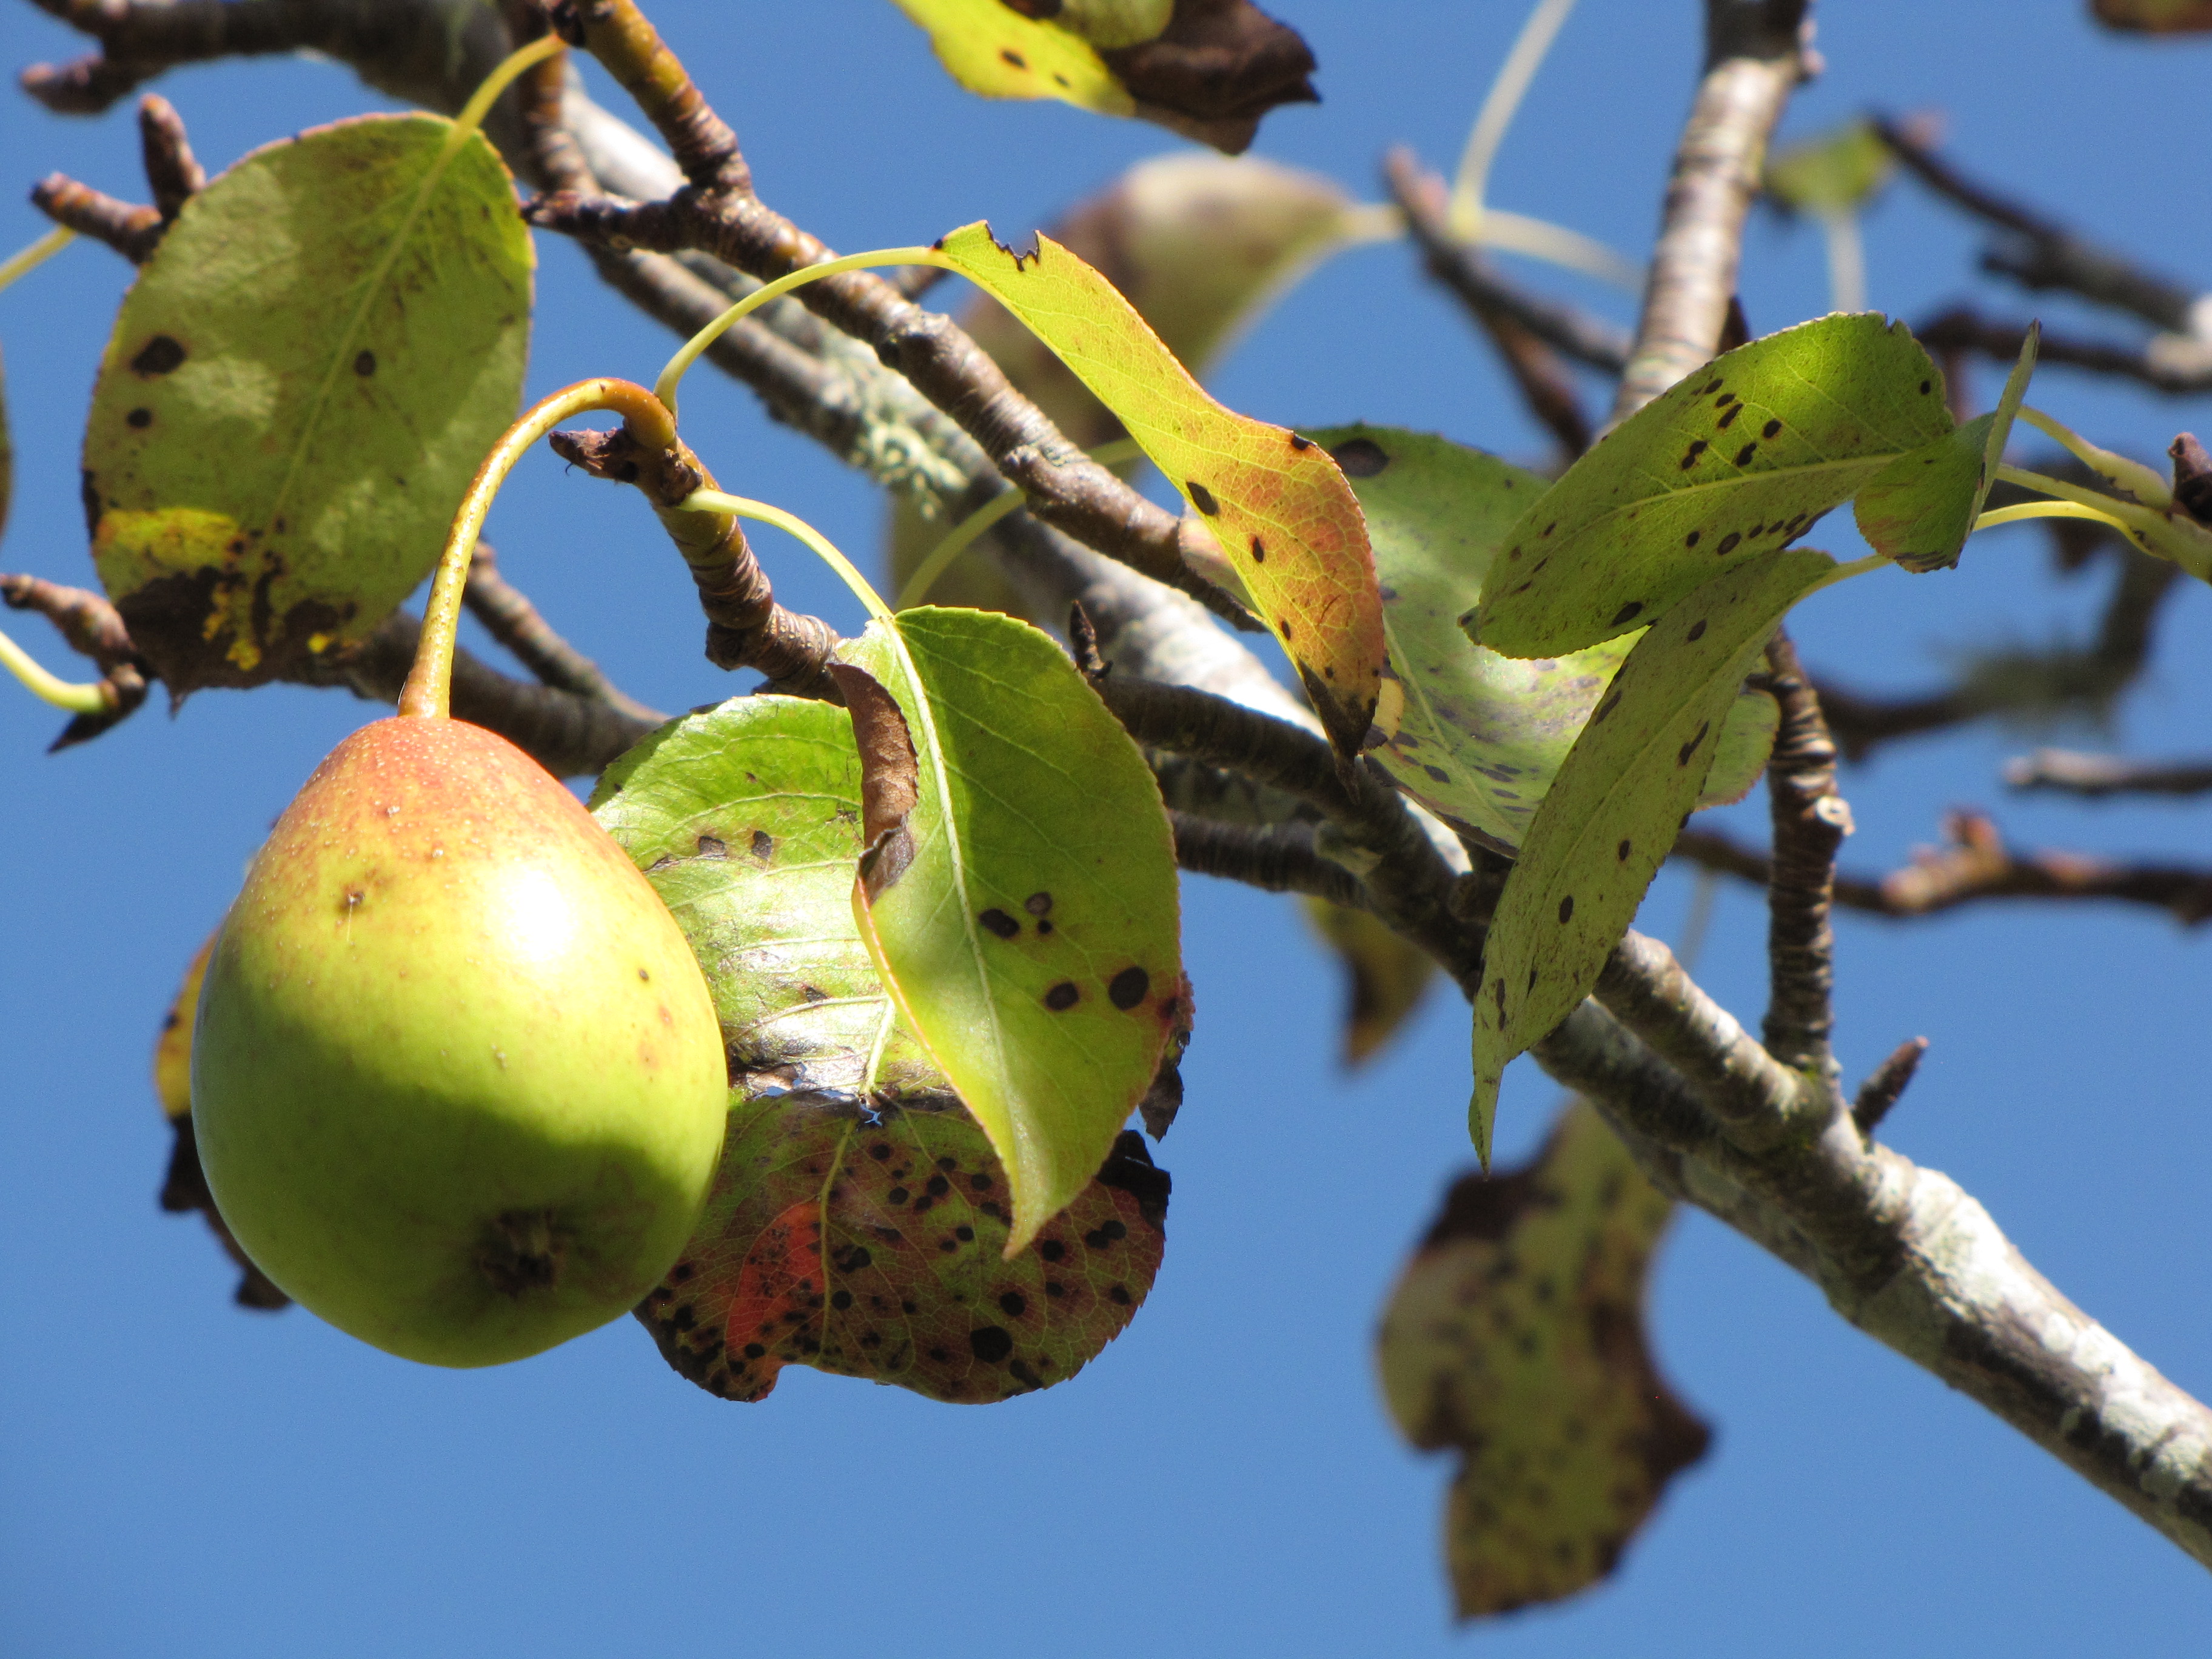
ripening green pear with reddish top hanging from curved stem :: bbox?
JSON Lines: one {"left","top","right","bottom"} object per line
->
{"left": 192, "top": 717, "right": 728, "bottom": 1365}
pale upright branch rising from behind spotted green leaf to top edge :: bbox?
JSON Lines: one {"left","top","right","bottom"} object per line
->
{"left": 1610, "top": 0, "right": 1812, "bottom": 424}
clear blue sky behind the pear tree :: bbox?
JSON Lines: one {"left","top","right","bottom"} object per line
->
{"left": 0, "top": 0, "right": 2212, "bottom": 1659}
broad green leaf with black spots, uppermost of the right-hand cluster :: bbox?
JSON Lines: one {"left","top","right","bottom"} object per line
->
{"left": 1471, "top": 314, "right": 1951, "bottom": 657}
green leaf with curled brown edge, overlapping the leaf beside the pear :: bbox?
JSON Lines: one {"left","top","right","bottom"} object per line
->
{"left": 839, "top": 608, "right": 1190, "bottom": 1250}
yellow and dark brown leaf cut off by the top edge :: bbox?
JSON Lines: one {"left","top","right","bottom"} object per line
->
{"left": 898, "top": 0, "right": 1318, "bottom": 155}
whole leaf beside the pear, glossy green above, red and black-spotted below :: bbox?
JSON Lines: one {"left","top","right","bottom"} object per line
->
{"left": 593, "top": 697, "right": 1168, "bottom": 1400}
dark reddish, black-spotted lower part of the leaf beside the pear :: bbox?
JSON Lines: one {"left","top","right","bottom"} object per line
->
{"left": 637, "top": 1095, "right": 1168, "bottom": 1403}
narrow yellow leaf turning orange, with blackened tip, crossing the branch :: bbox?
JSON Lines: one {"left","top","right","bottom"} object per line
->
{"left": 920, "top": 223, "right": 1385, "bottom": 757}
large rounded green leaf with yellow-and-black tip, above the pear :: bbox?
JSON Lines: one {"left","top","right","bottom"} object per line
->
{"left": 84, "top": 115, "right": 531, "bottom": 694}
